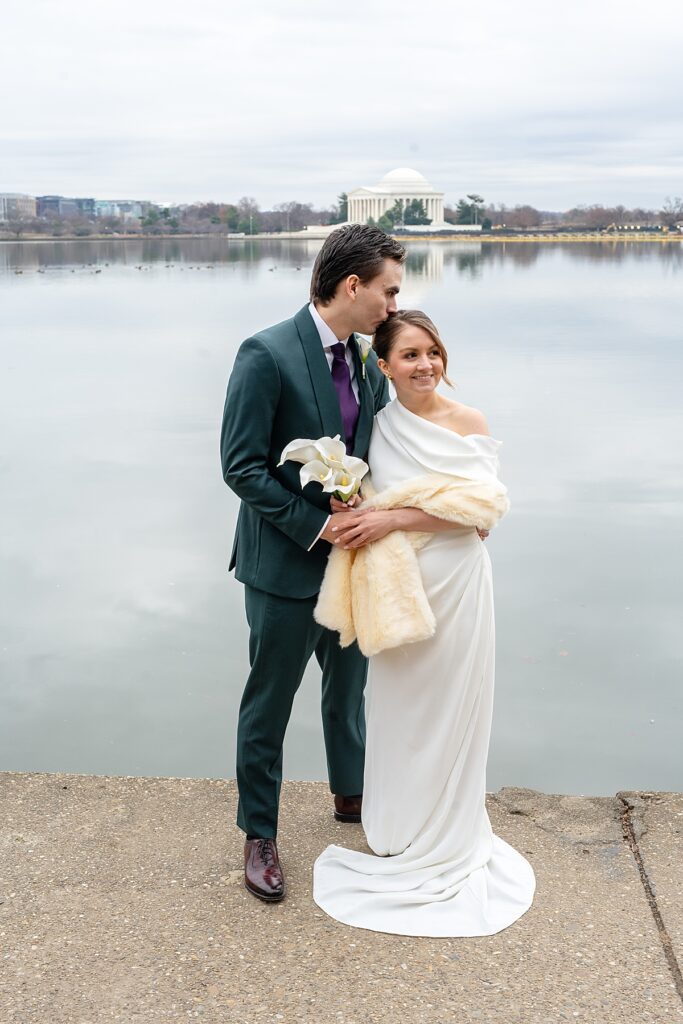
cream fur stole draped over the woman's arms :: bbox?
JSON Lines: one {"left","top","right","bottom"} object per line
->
{"left": 314, "top": 474, "right": 510, "bottom": 657}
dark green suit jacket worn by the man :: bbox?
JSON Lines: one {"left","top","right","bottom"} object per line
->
{"left": 220, "top": 306, "right": 389, "bottom": 598}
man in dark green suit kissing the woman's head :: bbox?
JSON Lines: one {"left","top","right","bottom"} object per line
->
{"left": 220, "top": 224, "right": 405, "bottom": 901}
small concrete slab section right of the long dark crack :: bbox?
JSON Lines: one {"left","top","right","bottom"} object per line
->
{"left": 620, "top": 793, "right": 683, "bottom": 983}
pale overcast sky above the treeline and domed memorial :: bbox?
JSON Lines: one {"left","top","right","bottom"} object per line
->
{"left": 0, "top": 0, "right": 683, "bottom": 209}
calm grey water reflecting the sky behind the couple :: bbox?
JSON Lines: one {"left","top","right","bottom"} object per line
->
{"left": 0, "top": 240, "right": 683, "bottom": 794}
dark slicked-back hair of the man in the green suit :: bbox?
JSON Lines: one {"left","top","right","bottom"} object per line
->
{"left": 310, "top": 224, "right": 405, "bottom": 305}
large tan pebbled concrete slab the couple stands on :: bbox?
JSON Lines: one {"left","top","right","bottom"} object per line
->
{"left": 0, "top": 774, "right": 683, "bottom": 1024}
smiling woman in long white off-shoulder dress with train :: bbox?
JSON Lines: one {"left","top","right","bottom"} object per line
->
{"left": 313, "top": 310, "right": 536, "bottom": 936}
